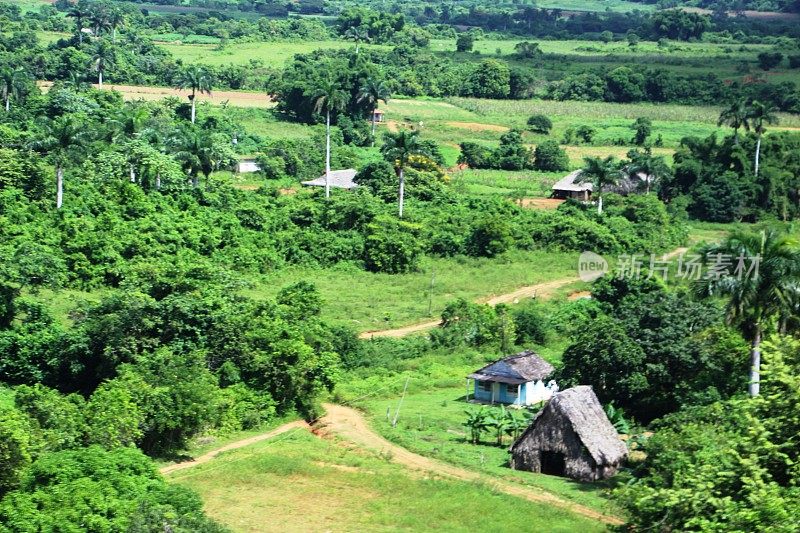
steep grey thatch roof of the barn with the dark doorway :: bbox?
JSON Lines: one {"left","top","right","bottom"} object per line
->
{"left": 511, "top": 385, "right": 628, "bottom": 465}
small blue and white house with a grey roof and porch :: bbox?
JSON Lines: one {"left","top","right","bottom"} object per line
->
{"left": 467, "top": 350, "right": 555, "bottom": 406}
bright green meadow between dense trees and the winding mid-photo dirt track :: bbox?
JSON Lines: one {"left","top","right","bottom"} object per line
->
{"left": 246, "top": 250, "right": 577, "bottom": 331}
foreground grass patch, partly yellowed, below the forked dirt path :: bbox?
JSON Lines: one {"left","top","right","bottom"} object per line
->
{"left": 168, "top": 430, "right": 604, "bottom": 533}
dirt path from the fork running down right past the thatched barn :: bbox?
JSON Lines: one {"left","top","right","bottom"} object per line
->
{"left": 314, "top": 404, "right": 623, "bottom": 525}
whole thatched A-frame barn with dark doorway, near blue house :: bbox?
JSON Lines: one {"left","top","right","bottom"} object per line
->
{"left": 510, "top": 385, "right": 628, "bottom": 481}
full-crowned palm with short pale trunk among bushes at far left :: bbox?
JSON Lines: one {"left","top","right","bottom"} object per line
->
{"left": 31, "top": 115, "right": 89, "bottom": 209}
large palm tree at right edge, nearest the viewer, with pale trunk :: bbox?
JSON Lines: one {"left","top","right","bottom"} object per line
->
{"left": 696, "top": 231, "right": 800, "bottom": 396}
